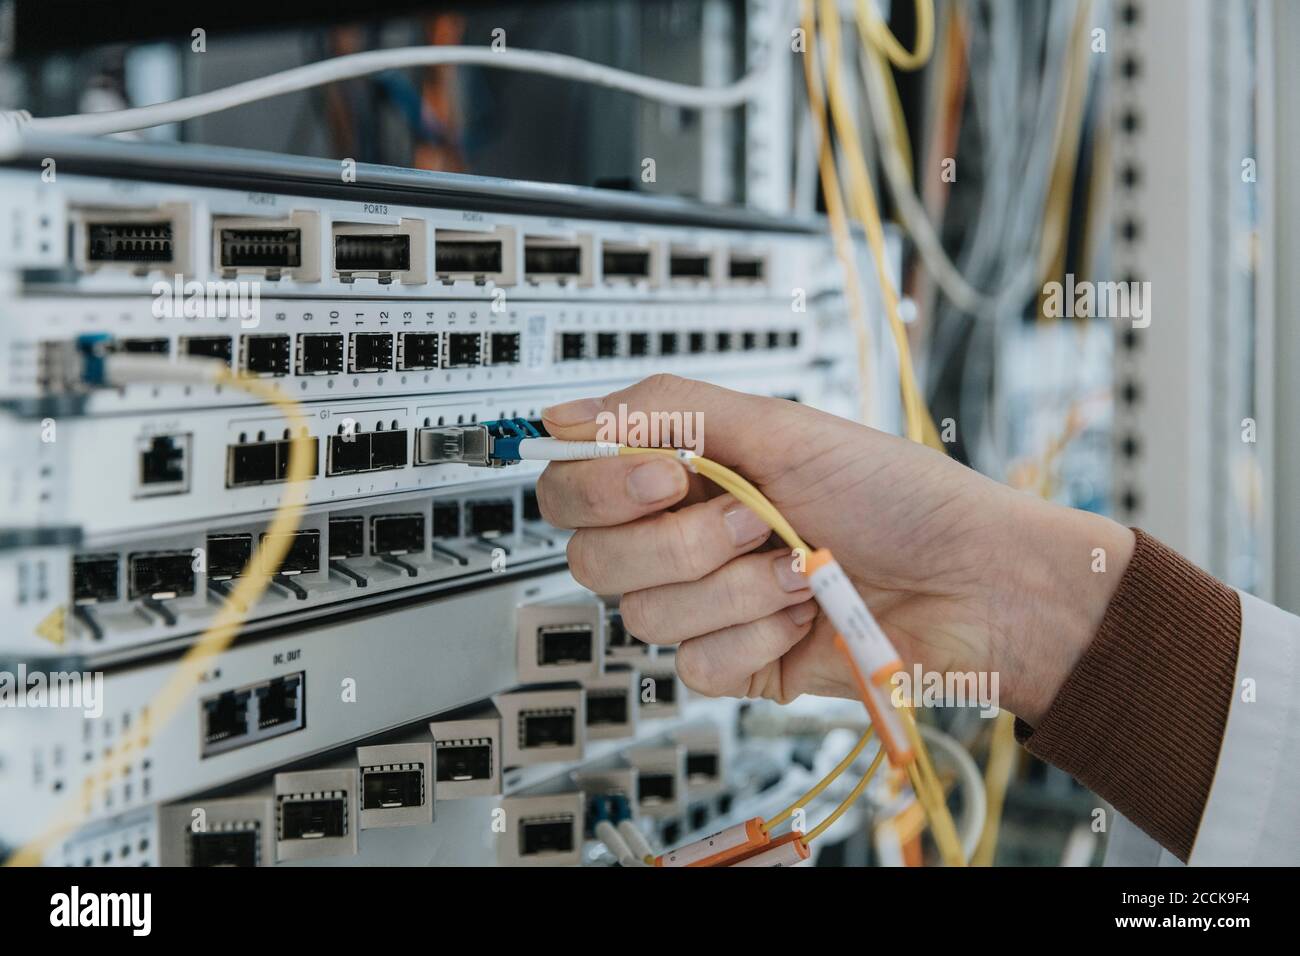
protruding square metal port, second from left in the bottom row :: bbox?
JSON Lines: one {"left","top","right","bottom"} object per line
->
{"left": 274, "top": 770, "right": 360, "bottom": 860}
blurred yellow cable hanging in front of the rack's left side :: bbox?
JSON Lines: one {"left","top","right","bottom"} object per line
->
{"left": 5, "top": 365, "right": 316, "bottom": 866}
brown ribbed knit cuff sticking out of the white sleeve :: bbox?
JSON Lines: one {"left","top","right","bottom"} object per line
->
{"left": 1015, "top": 528, "right": 1242, "bottom": 862}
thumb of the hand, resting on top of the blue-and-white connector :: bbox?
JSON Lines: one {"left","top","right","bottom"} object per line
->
{"left": 542, "top": 375, "right": 805, "bottom": 481}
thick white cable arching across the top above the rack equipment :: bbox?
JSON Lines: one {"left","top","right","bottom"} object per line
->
{"left": 10, "top": 47, "right": 764, "bottom": 137}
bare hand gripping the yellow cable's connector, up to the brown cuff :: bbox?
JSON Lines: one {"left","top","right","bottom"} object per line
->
{"left": 537, "top": 375, "right": 1132, "bottom": 723}
